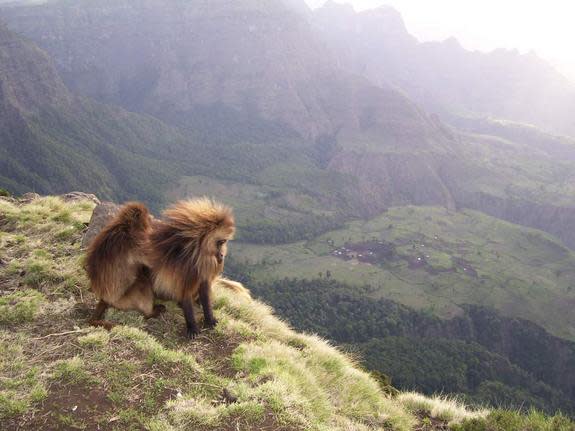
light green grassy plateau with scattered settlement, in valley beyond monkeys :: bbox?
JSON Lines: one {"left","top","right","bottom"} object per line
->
{"left": 232, "top": 207, "right": 575, "bottom": 339}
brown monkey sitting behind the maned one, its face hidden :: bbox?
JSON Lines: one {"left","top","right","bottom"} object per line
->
{"left": 86, "top": 202, "right": 161, "bottom": 326}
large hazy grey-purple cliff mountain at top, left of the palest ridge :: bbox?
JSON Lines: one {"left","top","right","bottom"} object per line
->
{"left": 0, "top": 0, "right": 444, "bottom": 139}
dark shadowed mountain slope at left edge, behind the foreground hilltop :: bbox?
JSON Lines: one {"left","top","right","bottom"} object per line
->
{"left": 0, "top": 23, "right": 205, "bottom": 206}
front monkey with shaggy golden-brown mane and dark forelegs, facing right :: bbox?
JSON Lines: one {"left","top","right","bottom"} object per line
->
{"left": 149, "top": 198, "right": 235, "bottom": 337}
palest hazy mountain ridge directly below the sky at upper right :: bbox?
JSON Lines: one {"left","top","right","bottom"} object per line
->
{"left": 314, "top": 1, "right": 575, "bottom": 135}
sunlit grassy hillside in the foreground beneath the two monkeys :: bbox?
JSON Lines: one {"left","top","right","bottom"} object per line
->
{"left": 0, "top": 198, "right": 486, "bottom": 430}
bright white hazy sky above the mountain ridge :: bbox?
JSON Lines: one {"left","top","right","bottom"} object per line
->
{"left": 306, "top": 0, "right": 575, "bottom": 77}
